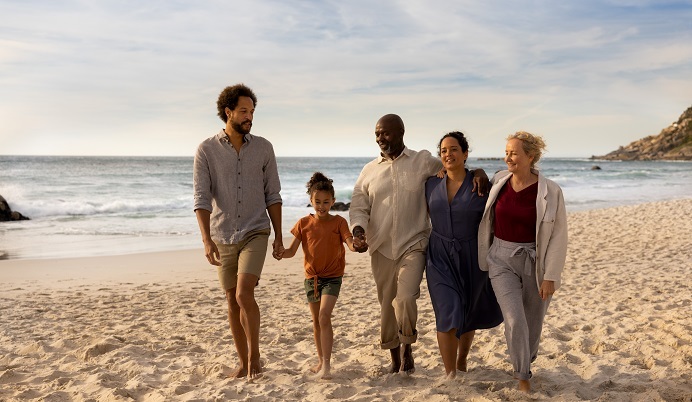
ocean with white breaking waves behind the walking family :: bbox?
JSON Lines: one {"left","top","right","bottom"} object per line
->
{"left": 0, "top": 155, "right": 692, "bottom": 259}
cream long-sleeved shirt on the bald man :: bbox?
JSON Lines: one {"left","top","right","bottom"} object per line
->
{"left": 349, "top": 147, "right": 442, "bottom": 260}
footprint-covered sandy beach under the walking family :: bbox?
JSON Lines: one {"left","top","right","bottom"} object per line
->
{"left": 0, "top": 199, "right": 692, "bottom": 402}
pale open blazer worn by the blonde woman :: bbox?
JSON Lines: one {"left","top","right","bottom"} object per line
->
{"left": 478, "top": 169, "right": 567, "bottom": 290}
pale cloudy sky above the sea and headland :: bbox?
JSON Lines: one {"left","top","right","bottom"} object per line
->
{"left": 0, "top": 0, "right": 692, "bottom": 157}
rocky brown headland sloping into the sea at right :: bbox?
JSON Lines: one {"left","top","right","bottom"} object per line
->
{"left": 591, "top": 107, "right": 692, "bottom": 161}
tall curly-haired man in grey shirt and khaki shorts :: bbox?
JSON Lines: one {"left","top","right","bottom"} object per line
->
{"left": 194, "top": 84, "right": 283, "bottom": 380}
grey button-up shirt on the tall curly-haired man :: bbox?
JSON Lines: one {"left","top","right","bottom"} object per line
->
{"left": 193, "top": 130, "right": 281, "bottom": 244}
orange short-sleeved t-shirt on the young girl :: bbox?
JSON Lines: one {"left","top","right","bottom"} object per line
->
{"left": 291, "top": 214, "right": 351, "bottom": 280}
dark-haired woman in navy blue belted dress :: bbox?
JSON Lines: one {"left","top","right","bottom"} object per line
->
{"left": 425, "top": 131, "right": 502, "bottom": 378}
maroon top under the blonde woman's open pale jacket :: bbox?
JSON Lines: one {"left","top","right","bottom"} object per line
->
{"left": 493, "top": 180, "right": 538, "bottom": 243}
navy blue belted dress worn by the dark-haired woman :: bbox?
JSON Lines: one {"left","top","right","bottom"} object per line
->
{"left": 425, "top": 170, "right": 502, "bottom": 338}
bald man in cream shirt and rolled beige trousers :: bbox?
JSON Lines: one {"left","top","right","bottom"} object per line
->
{"left": 349, "top": 114, "right": 488, "bottom": 374}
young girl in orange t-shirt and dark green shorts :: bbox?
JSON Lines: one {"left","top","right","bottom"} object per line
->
{"left": 281, "top": 172, "right": 355, "bottom": 379}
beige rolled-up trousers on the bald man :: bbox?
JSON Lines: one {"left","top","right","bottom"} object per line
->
{"left": 370, "top": 239, "right": 428, "bottom": 349}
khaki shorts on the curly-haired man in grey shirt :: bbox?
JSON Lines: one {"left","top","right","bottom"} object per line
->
{"left": 216, "top": 229, "right": 270, "bottom": 290}
